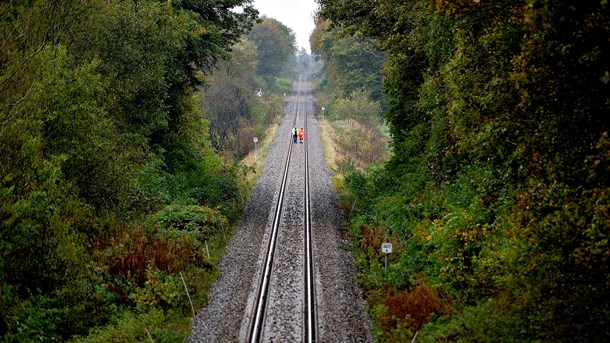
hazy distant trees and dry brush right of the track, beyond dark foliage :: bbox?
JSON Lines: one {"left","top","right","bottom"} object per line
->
{"left": 309, "top": 14, "right": 388, "bottom": 170}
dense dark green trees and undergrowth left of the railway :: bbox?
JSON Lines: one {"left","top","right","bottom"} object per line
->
{"left": 0, "top": 0, "right": 257, "bottom": 342}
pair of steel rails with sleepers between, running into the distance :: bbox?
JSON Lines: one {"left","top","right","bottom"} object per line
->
{"left": 245, "top": 75, "right": 318, "bottom": 343}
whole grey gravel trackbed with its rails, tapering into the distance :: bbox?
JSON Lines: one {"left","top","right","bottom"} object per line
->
{"left": 189, "top": 75, "right": 373, "bottom": 343}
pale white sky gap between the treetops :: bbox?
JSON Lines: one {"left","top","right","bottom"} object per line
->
{"left": 254, "top": 0, "right": 318, "bottom": 52}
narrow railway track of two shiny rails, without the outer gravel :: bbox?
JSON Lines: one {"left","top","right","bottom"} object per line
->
{"left": 246, "top": 75, "right": 317, "bottom": 342}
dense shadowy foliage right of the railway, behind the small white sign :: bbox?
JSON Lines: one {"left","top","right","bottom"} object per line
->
{"left": 319, "top": 0, "right": 610, "bottom": 342}
